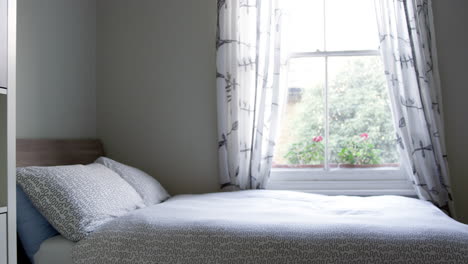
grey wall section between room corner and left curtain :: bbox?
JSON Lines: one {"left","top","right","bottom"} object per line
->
{"left": 97, "top": 0, "right": 218, "bottom": 194}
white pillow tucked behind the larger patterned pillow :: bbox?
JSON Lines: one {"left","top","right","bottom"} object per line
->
{"left": 95, "top": 157, "right": 170, "bottom": 206}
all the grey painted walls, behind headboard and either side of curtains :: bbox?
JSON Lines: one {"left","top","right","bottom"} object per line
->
{"left": 14, "top": 0, "right": 468, "bottom": 223}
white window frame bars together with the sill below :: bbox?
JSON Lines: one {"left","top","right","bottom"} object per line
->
{"left": 267, "top": 17, "right": 416, "bottom": 197}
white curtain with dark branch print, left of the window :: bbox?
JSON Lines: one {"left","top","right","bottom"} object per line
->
{"left": 216, "top": 0, "right": 281, "bottom": 190}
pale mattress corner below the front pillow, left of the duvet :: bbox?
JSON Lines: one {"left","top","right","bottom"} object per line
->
{"left": 34, "top": 235, "right": 75, "bottom": 264}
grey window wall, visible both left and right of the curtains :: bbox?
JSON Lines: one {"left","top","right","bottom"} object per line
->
{"left": 97, "top": 0, "right": 468, "bottom": 210}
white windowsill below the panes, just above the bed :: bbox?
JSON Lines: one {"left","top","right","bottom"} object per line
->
{"left": 266, "top": 167, "right": 416, "bottom": 197}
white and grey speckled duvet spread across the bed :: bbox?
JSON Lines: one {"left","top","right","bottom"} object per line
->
{"left": 72, "top": 190, "right": 468, "bottom": 264}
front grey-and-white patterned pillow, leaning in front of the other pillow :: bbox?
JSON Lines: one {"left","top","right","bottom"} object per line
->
{"left": 16, "top": 164, "right": 145, "bottom": 241}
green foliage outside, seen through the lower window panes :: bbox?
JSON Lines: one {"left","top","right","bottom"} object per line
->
{"left": 284, "top": 57, "right": 398, "bottom": 165}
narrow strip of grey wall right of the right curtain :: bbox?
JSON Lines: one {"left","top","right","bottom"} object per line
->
{"left": 433, "top": 0, "right": 468, "bottom": 223}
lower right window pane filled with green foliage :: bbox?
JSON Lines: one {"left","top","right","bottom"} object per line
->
{"left": 328, "top": 56, "right": 399, "bottom": 167}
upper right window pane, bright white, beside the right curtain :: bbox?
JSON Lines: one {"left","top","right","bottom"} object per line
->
{"left": 325, "top": 0, "right": 379, "bottom": 51}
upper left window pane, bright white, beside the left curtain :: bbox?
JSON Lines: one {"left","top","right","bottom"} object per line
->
{"left": 281, "top": 0, "right": 324, "bottom": 52}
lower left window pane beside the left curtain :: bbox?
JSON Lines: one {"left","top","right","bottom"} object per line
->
{"left": 273, "top": 58, "right": 325, "bottom": 167}
